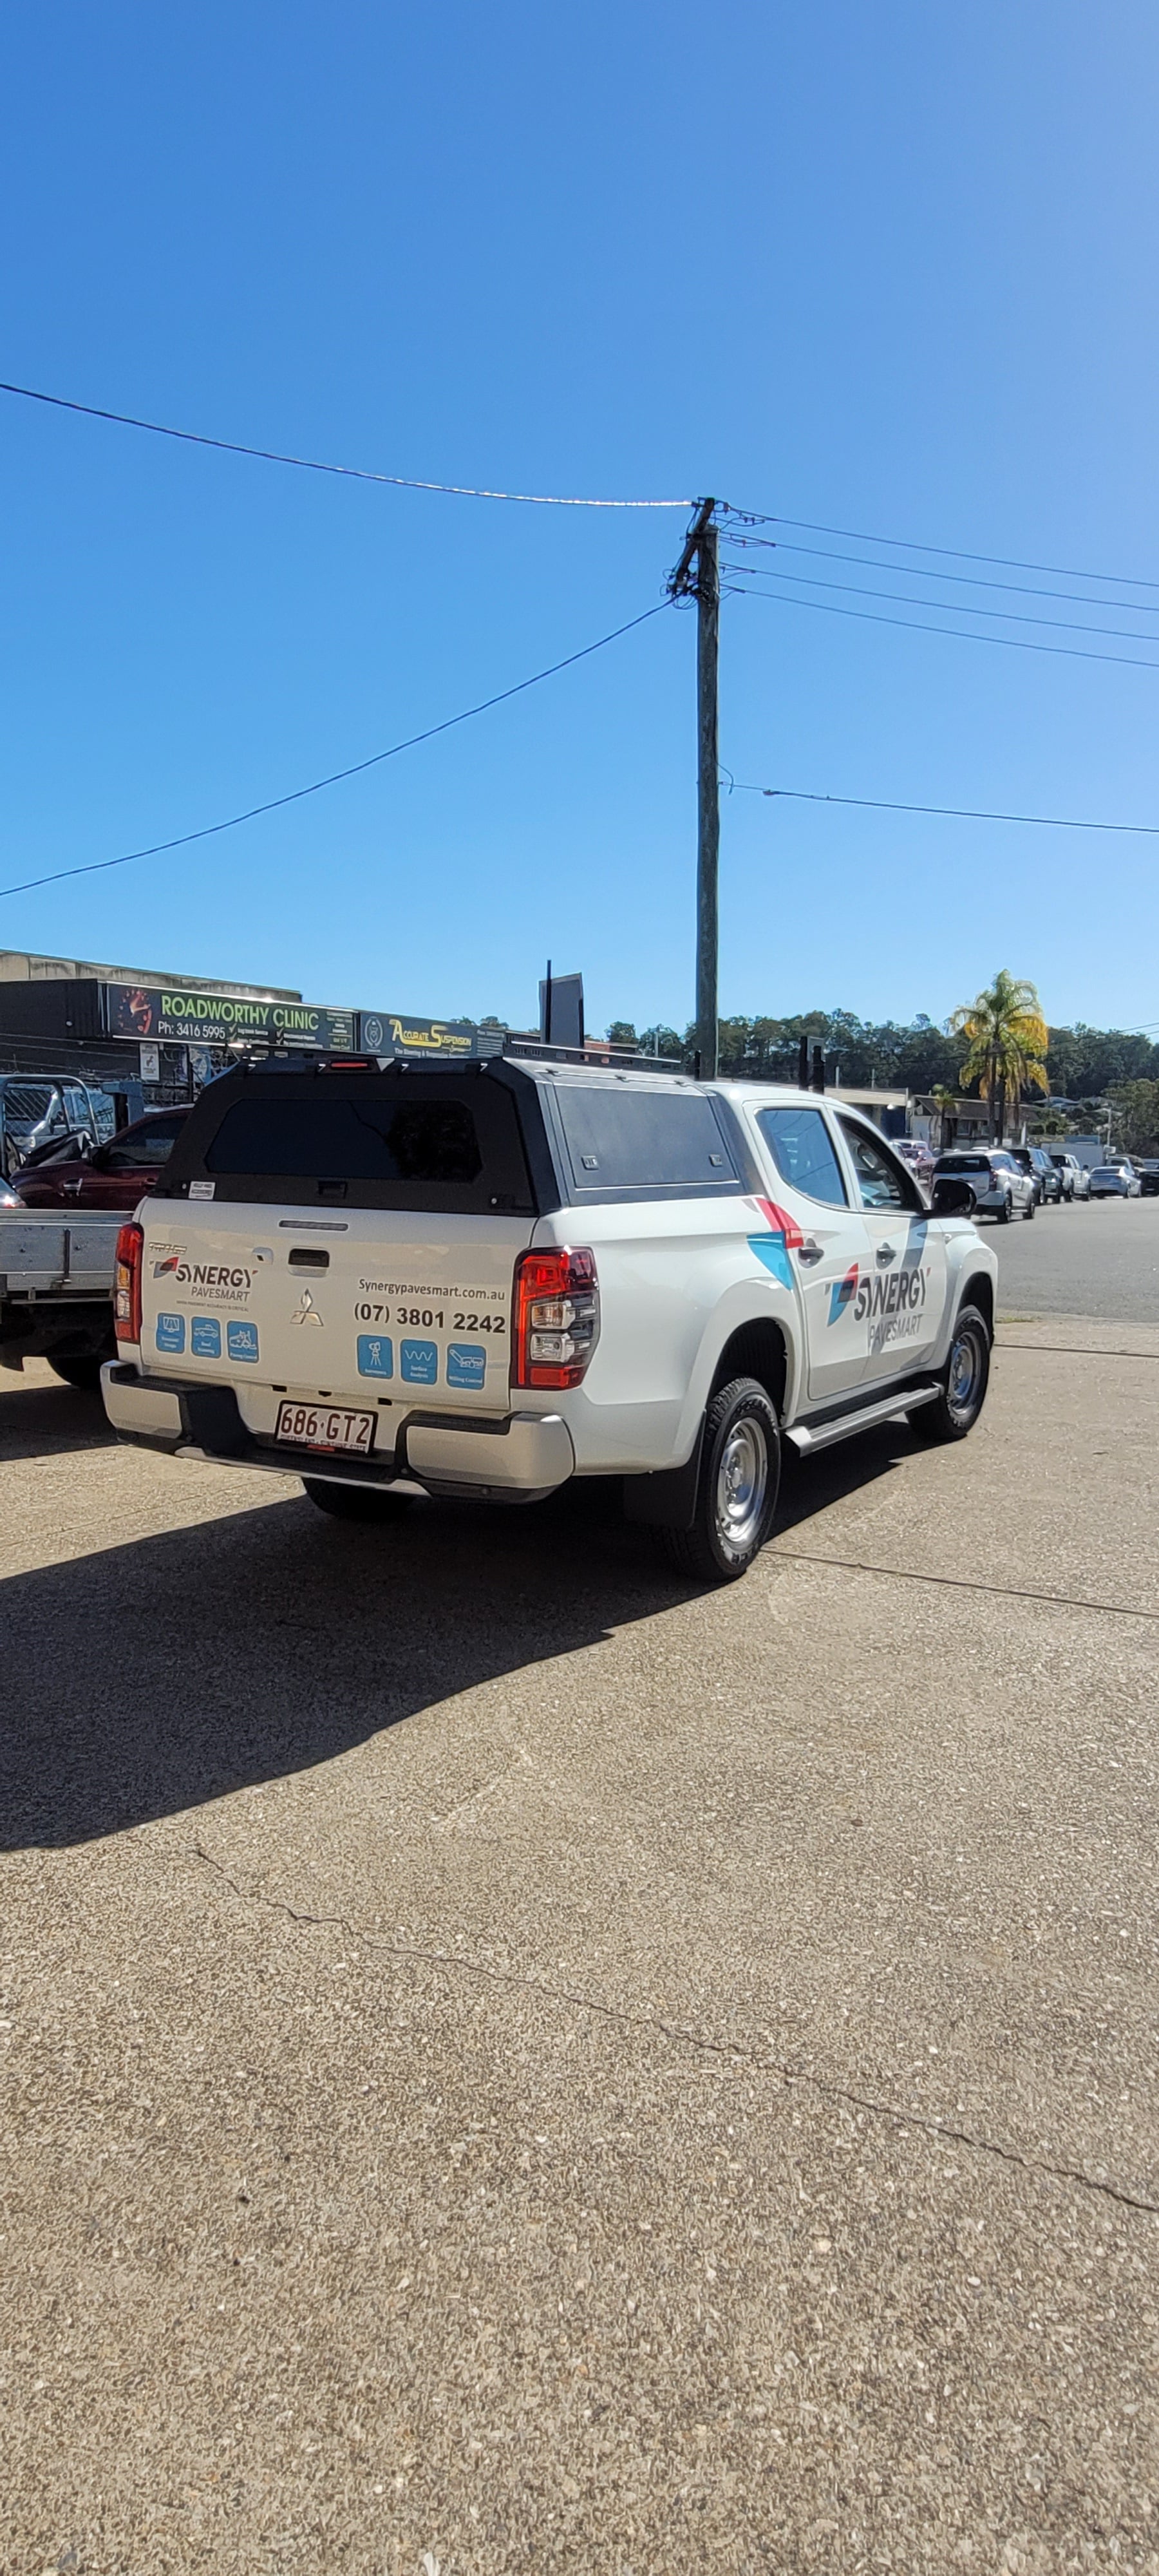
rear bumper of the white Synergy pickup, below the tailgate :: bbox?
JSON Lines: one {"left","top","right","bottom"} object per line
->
{"left": 100, "top": 1360, "right": 574, "bottom": 1502}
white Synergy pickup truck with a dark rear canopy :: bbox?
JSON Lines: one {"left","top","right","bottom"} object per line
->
{"left": 103, "top": 1054, "right": 997, "bottom": 1582}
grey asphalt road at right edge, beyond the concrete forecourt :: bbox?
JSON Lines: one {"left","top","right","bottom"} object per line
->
{"left": 981, "top": 1198, "right": 1159, "bottom": 1324}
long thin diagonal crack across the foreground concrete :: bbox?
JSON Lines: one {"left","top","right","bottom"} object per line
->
{"left": 193, "top": 1842, "right": 1159, "bottom": 2218}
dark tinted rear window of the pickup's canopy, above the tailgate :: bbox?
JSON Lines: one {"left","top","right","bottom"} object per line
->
{"left": 165, "top": 1072, "right": 531, "bottom": 1213}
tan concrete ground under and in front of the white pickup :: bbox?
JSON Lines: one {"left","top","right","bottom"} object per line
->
{"left": 0, "top": 1309, "right": 1159, "bottom": 2576}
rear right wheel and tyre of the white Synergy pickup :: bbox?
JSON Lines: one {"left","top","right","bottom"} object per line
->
{"left": 662, "top": 1378, "right": 780, "bottom": 1584}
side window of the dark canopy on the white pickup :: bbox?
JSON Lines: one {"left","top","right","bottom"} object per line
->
{"left": 556, "top": 1079, "right": 739, "bottom": 1198}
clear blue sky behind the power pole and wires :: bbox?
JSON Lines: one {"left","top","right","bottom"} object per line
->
{"left": 0, "top": 0, "right": 1159, "bottom": 1025}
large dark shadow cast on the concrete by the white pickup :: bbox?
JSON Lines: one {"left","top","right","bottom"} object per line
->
{"left": 0, "top": 1432, "right": 922, "bottom": 1850}
